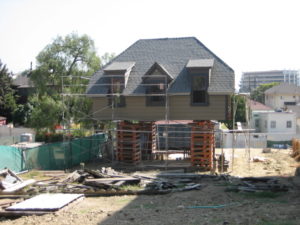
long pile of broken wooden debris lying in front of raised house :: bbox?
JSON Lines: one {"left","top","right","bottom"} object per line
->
{"left": 26, "top": 167, "right": 207, "bottom": 196}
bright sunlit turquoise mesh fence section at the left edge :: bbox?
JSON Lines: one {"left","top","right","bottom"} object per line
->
{"left": 0, "top": 146, "right": 24, "bottom": 172}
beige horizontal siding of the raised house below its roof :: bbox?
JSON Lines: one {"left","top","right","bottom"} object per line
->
{"left": 93, "top": 95, "right": 226, "bottom": 121}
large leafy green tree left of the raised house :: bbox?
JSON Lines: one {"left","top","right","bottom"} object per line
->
{"left": 29, "top": 33, "right": 103, "bottom": 130}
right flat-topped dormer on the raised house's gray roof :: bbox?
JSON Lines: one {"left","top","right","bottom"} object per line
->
{"left": 186, "top": 59, "right": 214, "bottom": 106}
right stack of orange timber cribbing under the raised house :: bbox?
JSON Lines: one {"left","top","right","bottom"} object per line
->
{"left": 191, "top": 121, "right": 215, "bottom": 170}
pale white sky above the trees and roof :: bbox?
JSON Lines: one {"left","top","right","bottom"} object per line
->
{"left": 0, "top": 0, "right": 300, "bottom": 88}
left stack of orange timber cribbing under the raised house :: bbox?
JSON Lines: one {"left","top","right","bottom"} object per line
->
{"left": 116, "top": 121, "right": 152, "bottom": 164}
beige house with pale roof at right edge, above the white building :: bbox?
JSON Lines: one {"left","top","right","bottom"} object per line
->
{"left": 265, "top": 83, "right": 300, "bottom": 109}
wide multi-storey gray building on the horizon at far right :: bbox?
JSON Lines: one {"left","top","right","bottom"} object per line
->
{"left": 240, "top": 70, "right": 300, "bottom": 92}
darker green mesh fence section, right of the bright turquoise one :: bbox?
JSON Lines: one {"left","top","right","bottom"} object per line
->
{"left": 23, "top": 134, "right": 106, "bottom": 170}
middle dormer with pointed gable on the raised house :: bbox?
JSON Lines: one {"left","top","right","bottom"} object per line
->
{"left": 143, "top": 63, "right": 173, "bottom": 106}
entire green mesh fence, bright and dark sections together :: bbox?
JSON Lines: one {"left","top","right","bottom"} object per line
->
{"left": 0, "top": 134, "right": 106, "bottom": 172}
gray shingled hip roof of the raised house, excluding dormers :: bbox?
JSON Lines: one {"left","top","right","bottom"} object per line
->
{"left": 87, "top": 37, "right": 234, "bottom": 95}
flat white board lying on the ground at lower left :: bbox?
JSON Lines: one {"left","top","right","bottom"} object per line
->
{"left": 5, "top": 194, "right": 84, "bottom": 212}
